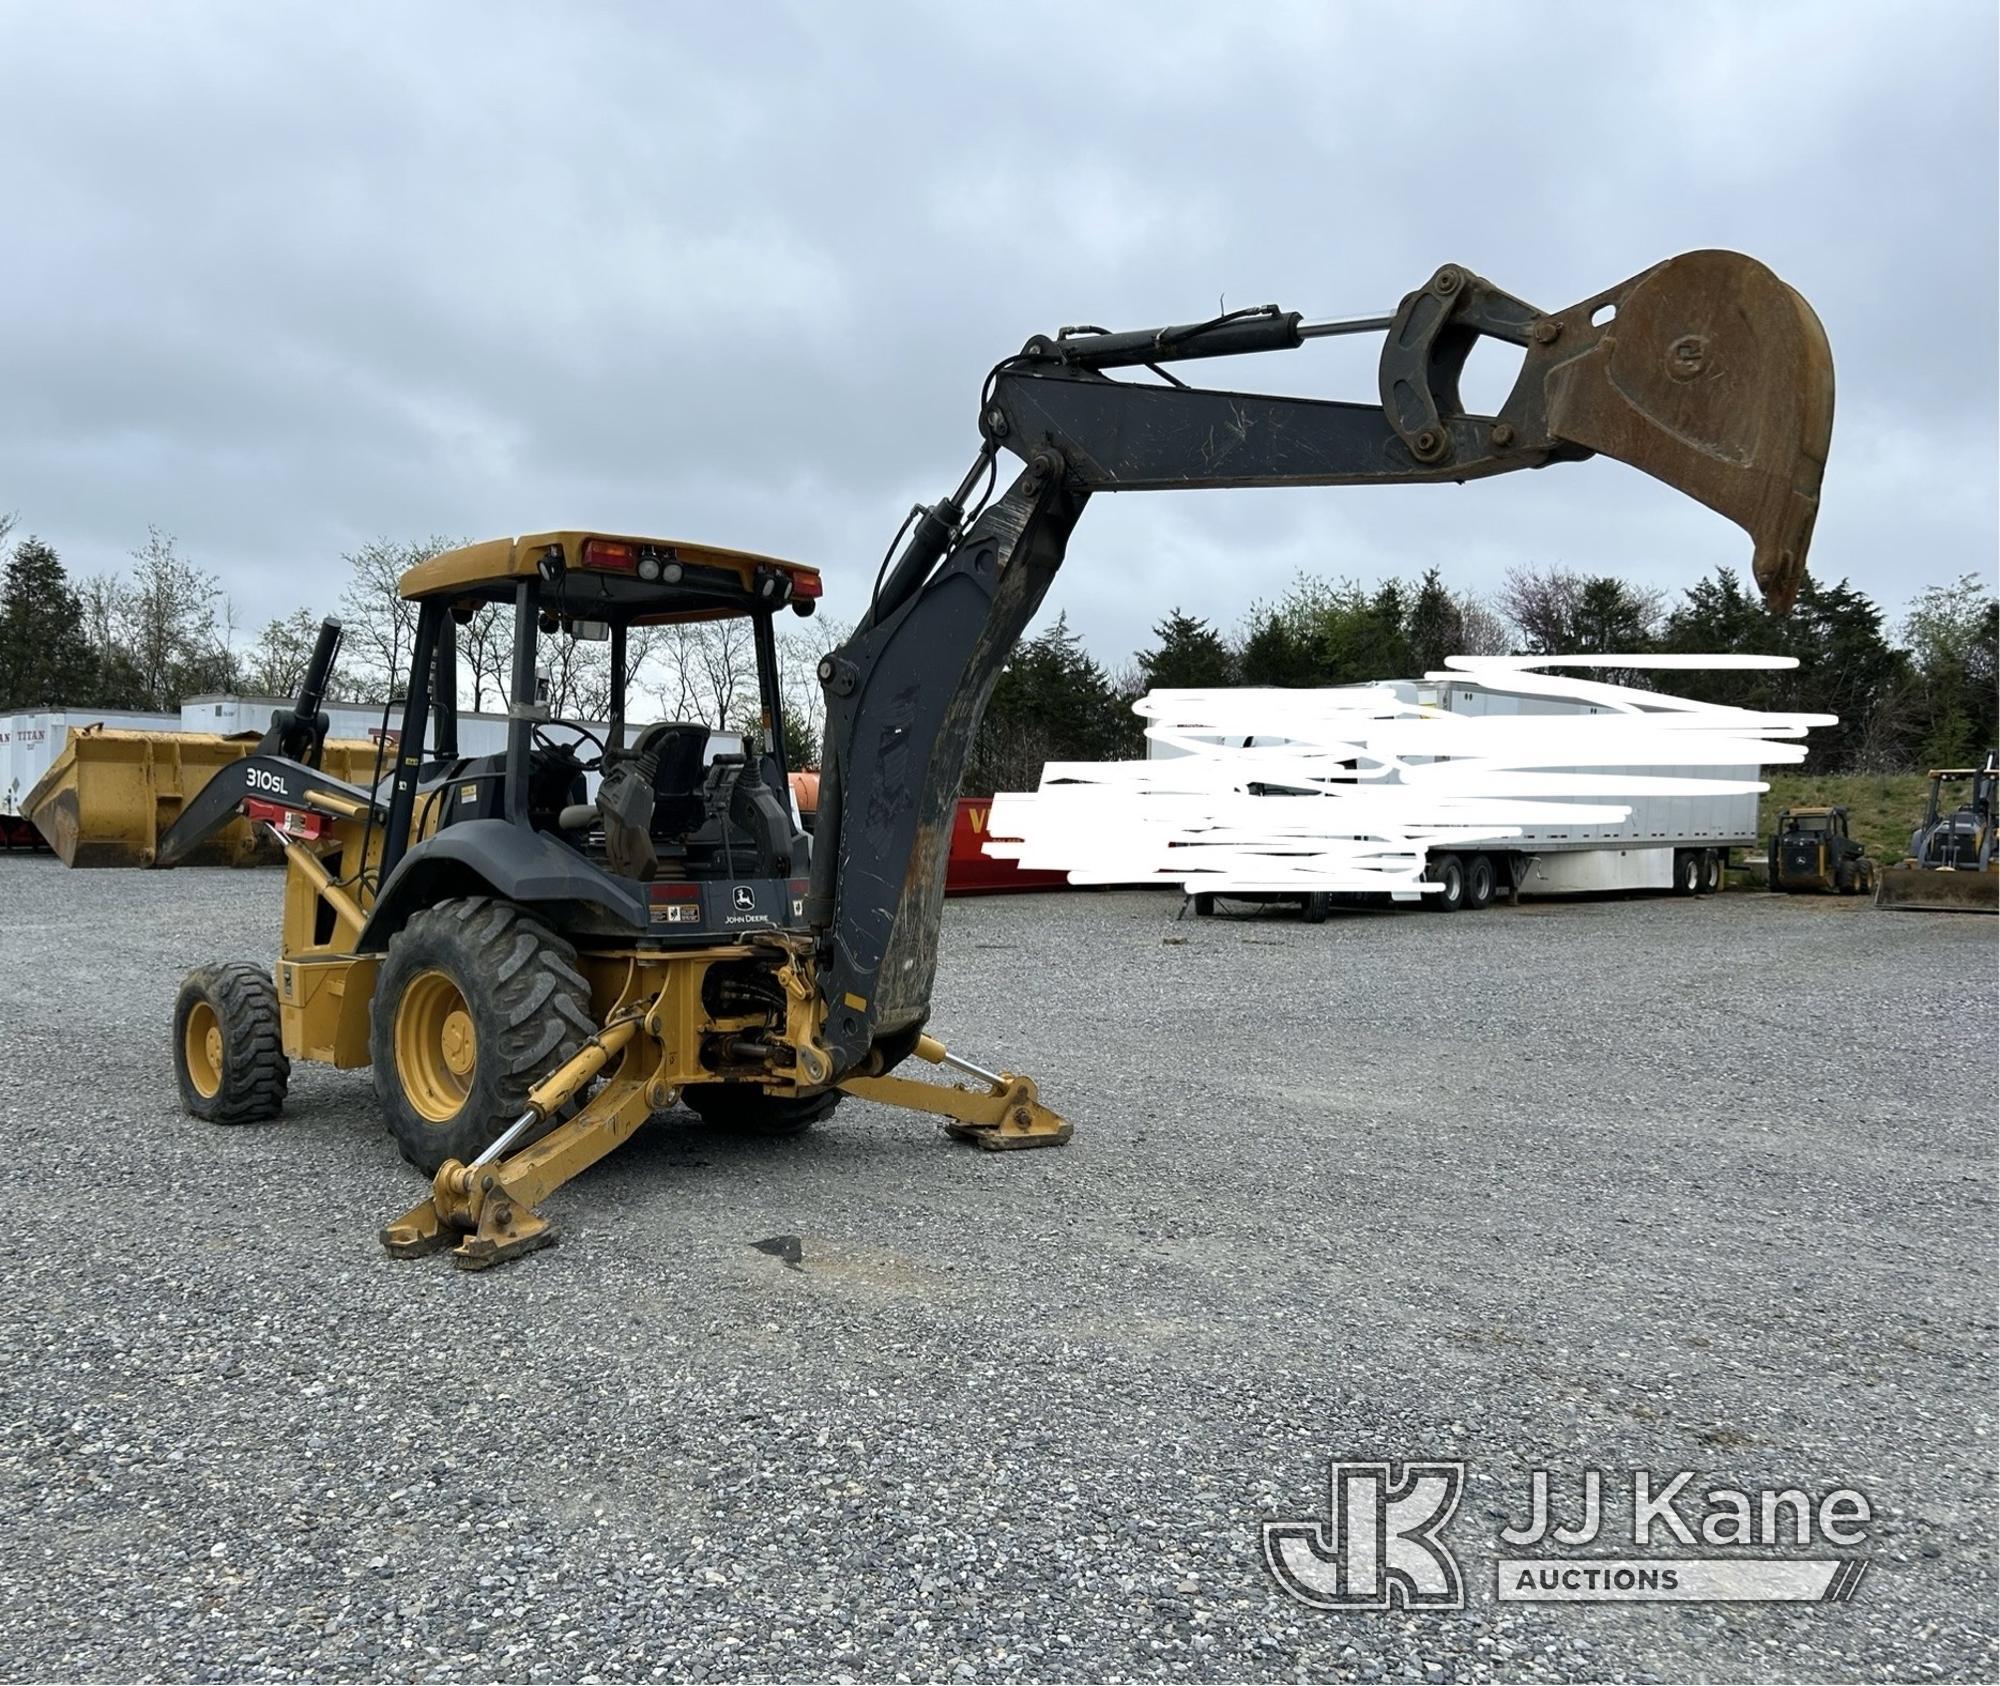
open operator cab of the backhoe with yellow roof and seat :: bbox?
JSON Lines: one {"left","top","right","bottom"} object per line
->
{"left": 382, "top": 532, "right": 820, "bottom": 940}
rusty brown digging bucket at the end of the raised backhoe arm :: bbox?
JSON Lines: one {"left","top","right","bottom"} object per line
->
{"left": 1534, "top": 252, "right": 1834, "bottom": 614}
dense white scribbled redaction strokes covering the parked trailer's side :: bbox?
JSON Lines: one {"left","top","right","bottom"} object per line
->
{"left": 986, "top": 656, "right": 1838, "bottom": 894}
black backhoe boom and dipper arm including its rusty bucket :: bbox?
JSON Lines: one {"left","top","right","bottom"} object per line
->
{"left": 808, "top": 252, "right": 1834, "bottom": 1076}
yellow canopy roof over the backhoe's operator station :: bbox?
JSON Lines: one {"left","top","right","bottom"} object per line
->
{"left": 396, "top": 530, "right": 820, "bottom": 622}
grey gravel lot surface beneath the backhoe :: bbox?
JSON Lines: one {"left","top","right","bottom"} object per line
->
{"left": 0, "top": 858, "right": 1996, "bottom": 1682}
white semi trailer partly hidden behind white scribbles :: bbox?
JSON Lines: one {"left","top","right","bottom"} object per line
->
{"left": 1148, "top": 674, "right": 1760, "bottom": 920}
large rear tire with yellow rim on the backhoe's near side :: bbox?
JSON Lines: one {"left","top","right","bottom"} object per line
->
{"left": 368, "top": 896, "right": 598, "bottom": 1174}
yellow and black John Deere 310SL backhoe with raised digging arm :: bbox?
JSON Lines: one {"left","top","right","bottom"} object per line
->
{"left": 160, "top": 252, "right": 1834, "bottom": 1268}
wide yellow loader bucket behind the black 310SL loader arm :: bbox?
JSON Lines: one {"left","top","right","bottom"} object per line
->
{"left": 22, "top": 726, "right": 376, "bottom": 866}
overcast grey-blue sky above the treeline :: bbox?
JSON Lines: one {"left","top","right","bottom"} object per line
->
{"left": 0, "top": 0, "right": 1996, "bottom": 664}
